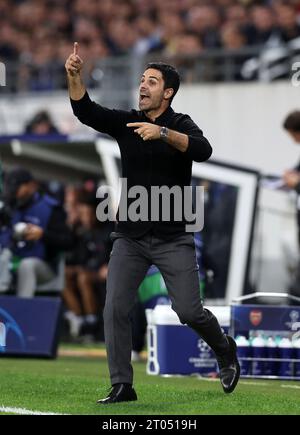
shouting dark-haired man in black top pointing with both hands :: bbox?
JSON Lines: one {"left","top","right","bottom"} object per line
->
{"left": 66, "top": 43, "right": 239, "bottom": 404}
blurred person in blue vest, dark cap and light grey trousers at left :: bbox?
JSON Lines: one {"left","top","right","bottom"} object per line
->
{"left": 4, "top": 168, "right": 72, "bottom": 298}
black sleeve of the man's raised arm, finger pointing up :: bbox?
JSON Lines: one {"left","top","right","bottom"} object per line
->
{"left": 70, "top": 92, "right": 128, "bottom": 137}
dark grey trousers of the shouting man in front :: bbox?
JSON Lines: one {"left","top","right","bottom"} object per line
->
{"left": 104, "top": 233, "right": 228, "bottom": 385}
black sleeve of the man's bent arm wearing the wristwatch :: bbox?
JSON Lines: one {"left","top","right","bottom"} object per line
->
{"left": 178, "top": 115, "right": 212, "bottom": 162}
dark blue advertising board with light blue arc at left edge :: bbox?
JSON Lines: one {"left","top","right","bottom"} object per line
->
{"left": 0, "top": 296, "right": 61, "bottom": 358}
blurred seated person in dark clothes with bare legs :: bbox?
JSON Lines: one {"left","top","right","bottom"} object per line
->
{"left": 64, "top": 191, "right": 113, "bottom": 341}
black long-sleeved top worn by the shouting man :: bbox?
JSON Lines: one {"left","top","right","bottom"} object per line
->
{"left": 71, "top": 92, "right": 212, "bottom": 238}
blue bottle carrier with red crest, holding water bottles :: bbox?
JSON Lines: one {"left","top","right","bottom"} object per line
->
{"left": 230, "top": 305, "right": 300, "bottom": 380}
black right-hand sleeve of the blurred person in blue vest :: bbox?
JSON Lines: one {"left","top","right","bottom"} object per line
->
{"left": 43, "top": 207, "right": 74, "bottom": 251}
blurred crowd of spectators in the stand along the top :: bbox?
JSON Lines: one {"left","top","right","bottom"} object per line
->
{"left": 0, "top": 0, "right": 300, "bottom": 91}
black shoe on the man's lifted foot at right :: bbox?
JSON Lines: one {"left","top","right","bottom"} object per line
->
{"left": 217, "top": 335, "right": 240, "bottom": 393}
